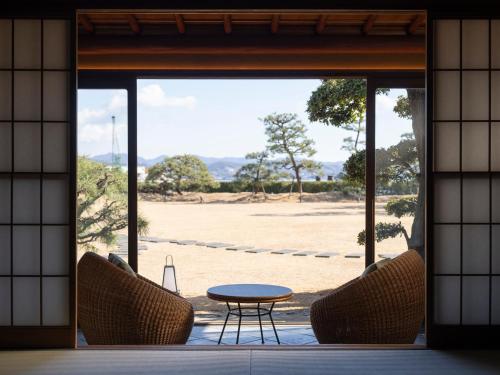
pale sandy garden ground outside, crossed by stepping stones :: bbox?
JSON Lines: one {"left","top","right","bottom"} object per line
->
{"left": 79, "top": 193, "right": 412, "bottom": 322}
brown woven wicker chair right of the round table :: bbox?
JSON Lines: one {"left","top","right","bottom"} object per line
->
{"left": 311, "top": 250, "right": 425, "bottom": 344}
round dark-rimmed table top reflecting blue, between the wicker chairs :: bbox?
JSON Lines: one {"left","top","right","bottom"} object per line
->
{"left": 207, "top": 284, "right": 293, "bottom": 303}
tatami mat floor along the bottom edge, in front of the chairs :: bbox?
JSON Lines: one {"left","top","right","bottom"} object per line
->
{"left": 0, "top": 348, "right": 500, "bottom": 375}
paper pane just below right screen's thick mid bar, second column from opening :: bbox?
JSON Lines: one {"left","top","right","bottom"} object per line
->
{"left": 462, "top": 178, "right": 490, "bottom": 223}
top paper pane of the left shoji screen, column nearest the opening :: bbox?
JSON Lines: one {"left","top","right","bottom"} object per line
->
{"left": 43, "top": 20, "right": 69, "bottom": 69}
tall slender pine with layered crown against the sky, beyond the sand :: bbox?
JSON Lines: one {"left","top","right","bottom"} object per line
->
{"left": 262, "top": 113, "right": 321, "bottom": 202}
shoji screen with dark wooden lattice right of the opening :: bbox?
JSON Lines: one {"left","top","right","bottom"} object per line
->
{"left": 428, "top": 19, "right": 500, "bottom": 344}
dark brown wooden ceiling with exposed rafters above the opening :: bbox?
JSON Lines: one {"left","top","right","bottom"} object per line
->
{"left": 78, "top": 12, "right": 426, "bottom": 70}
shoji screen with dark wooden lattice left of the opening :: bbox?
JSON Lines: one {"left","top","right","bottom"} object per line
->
{"left": 0, "top": 18, "right": 76, "bottom": 346}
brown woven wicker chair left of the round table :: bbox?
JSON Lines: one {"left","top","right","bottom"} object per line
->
{"left": 78, "top": 252, "right": 194, "bottom": 345}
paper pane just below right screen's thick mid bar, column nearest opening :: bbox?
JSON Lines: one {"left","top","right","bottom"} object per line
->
{"left": 434, "top": 178, "right": 460, "bottom": 223}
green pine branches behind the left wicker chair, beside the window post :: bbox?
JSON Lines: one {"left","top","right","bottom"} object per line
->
{"left": 76, "top": 156, "right": 148, "bottom": 251}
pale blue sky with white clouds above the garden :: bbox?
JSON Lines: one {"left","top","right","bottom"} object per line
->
{"left": 78, "top": 79, "right": 411, "bottom": 161}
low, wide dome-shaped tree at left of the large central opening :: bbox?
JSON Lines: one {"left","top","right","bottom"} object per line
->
{"left": 146, "top": 154, "right": 219, "bottom": 195}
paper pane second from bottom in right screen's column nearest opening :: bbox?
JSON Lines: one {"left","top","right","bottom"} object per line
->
{"left": 434, "top": 225, "right": 460, "bottom": 274}
